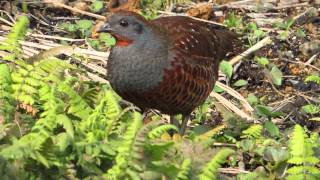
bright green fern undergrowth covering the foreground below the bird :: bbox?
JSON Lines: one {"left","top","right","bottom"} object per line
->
{"left": 0, "top": 12, "right": 320, "bottom": 180}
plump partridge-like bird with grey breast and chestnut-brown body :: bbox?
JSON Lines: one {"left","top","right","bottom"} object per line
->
{"left": 98, "top": 10, "right": 241, "bottom": 135}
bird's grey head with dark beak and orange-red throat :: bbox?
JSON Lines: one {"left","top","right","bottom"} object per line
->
{"left": 98, "top": 11, "right": 148, "bottom": 46}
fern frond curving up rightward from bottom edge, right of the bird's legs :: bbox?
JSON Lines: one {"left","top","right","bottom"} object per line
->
{"left": 199, "top": 148, "right": 234, "bottom": 180}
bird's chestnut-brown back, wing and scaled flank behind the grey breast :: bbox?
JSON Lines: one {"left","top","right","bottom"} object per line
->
{"left": 141, "top": 16, "right": 240, "bottom": 114}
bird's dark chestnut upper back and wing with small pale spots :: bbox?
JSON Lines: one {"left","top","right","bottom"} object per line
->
{"left": 152, "top": 16, "right": 240, "bottom": 61}
